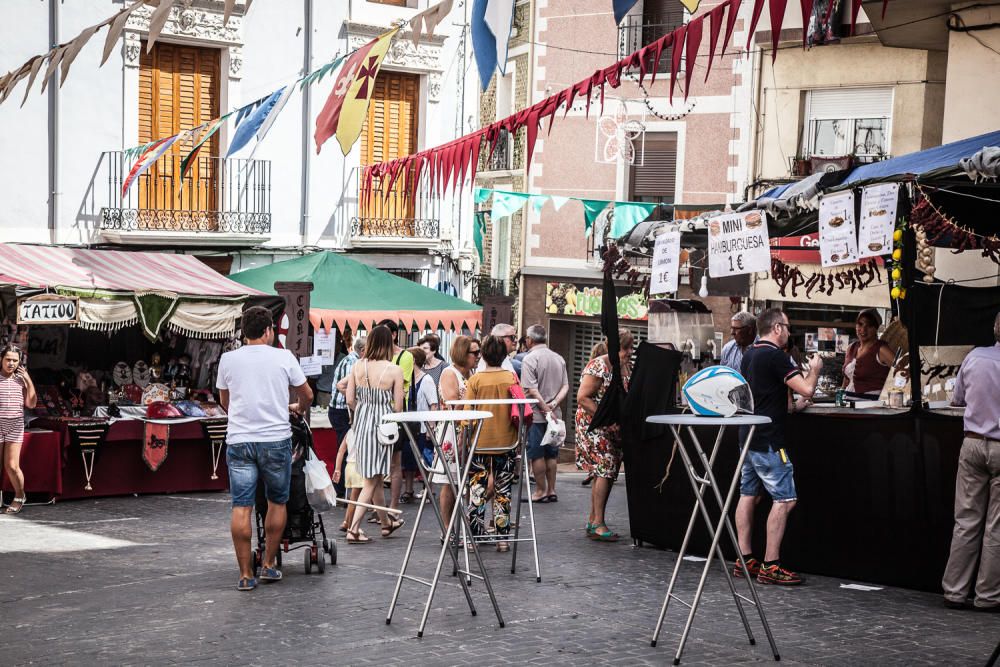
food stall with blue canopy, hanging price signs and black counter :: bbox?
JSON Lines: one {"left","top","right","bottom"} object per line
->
{"left": 626, "top": 132, "right": 1000, "bottom": 591}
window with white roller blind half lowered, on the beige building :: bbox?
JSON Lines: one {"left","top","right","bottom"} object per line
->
{"left": 803, "top": 88, "right": 892, "bottom": 158}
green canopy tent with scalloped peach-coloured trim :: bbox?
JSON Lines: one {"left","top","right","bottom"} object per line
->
{"left": 229, "top": 251, "right": 483, "bottom": 331}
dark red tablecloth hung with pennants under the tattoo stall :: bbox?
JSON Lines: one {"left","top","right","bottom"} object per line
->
{"left": 32, "top": 419, "right": 229, "bottom": 499}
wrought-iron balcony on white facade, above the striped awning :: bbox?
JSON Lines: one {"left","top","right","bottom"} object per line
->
{"left": 100, "top": 151, "right": 271, "bottom": 247}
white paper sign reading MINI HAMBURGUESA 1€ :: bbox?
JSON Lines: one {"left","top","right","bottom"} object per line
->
{"left": 708, "top": 211, "right": 771, "bottom": 278}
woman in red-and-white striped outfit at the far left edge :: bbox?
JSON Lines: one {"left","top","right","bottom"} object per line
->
{"left": 0, "top": 345, "right": 38, "bottom": 514}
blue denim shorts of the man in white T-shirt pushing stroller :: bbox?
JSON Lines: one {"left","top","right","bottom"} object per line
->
{"left": 226, "top": 438, "right": 292, "bottom": 507}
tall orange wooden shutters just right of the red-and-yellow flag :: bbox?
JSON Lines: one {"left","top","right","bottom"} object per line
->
{"left": 359, "top": 70, "right": 420, "bottom": 226}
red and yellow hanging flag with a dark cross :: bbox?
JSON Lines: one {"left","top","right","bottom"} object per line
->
{"left": 314, "top": 28, "right": 399, "bottom": 155}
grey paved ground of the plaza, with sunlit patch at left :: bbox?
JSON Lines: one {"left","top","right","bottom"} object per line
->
{"left": 0, "top": 474, "right": 1000, "bottom": 665}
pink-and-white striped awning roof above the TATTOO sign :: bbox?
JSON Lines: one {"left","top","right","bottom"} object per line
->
{"left": 0, "top": 243, "right": 262, "bottom": 298}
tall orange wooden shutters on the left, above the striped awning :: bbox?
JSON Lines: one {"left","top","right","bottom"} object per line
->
{"left": 138, "top": 42, "right": 219, "bottom": 218}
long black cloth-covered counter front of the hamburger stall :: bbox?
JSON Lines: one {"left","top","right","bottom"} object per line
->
{"left": 625, "top": 408, "right": 963, "bottom": 592}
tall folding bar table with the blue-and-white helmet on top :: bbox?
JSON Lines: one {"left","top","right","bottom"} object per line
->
{"left": 646, "top": 414, "right": 781, "bottom": 665}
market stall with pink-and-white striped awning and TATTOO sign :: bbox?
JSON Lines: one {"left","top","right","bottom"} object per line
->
{"left": 0, "top": 244, "right": 263, "bottom": 498}
